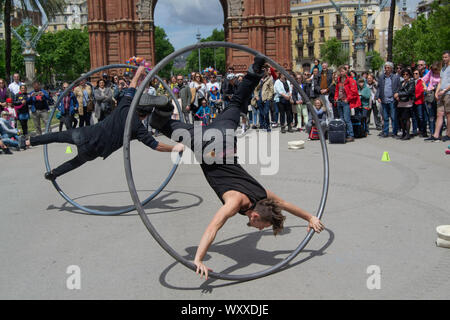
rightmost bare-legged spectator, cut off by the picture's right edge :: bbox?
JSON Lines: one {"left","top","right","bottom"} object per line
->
{"left": 425, "top": 51, "right": 450, "bottom": 141}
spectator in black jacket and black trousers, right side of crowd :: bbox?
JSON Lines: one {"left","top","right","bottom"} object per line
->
{"left": 396, "top": 69, "right": 415, "bottom": 140}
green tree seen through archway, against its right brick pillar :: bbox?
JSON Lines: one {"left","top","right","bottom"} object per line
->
{"left": 186, "top": 29, "right": 226, "bottom": 74}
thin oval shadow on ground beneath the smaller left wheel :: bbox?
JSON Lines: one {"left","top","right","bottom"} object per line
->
{"left": 47, "top": 190, "right": 203, "bottom": 216}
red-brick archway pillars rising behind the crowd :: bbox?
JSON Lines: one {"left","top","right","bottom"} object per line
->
{"left": 88, "top": 0, "right": 292, "bottom": 71}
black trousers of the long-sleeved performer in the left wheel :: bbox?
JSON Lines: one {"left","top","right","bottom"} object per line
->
{"left": 30, "top": 129, "right": 96, "bottom": 177}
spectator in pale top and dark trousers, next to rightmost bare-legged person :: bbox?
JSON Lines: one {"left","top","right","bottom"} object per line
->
{"left": 422, "top": 62, "right": 441, "bottom": 135}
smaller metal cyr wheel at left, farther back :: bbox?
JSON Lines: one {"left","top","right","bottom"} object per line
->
{"left": 44, "top": 64, "right": 184, "bottom": 216}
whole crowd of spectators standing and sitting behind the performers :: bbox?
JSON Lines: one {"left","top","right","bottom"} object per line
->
{"left": 0, "top": 51, "right": 450, "bottom": 153}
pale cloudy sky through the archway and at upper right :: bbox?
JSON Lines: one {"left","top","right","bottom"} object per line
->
{"left": 155, "top": 0, "right": 420, "bottom": 49}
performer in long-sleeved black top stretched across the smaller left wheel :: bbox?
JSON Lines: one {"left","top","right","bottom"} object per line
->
{"left": 26, "top": 66, "right": 184, "bottom": 180}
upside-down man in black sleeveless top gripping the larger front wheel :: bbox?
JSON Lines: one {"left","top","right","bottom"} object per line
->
{"left": 140, "top": 57, "right": 324, "bottom": 279}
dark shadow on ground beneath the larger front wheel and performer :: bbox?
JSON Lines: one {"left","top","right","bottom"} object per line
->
{"left": 159, "top": 226, "right": 334, "bottom": 293}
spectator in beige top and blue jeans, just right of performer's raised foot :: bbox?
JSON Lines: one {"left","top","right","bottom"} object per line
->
{"left": 253, "top": 69, "right": 274, "bottom": 132}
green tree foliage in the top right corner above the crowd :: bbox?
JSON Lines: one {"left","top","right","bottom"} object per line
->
{"left": 393, "top": 1, "right": 450, "bottom": 65}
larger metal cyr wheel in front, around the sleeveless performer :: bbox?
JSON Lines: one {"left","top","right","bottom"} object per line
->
{"left": 123, "top": 42, "right": 329, "bottom": 281}
